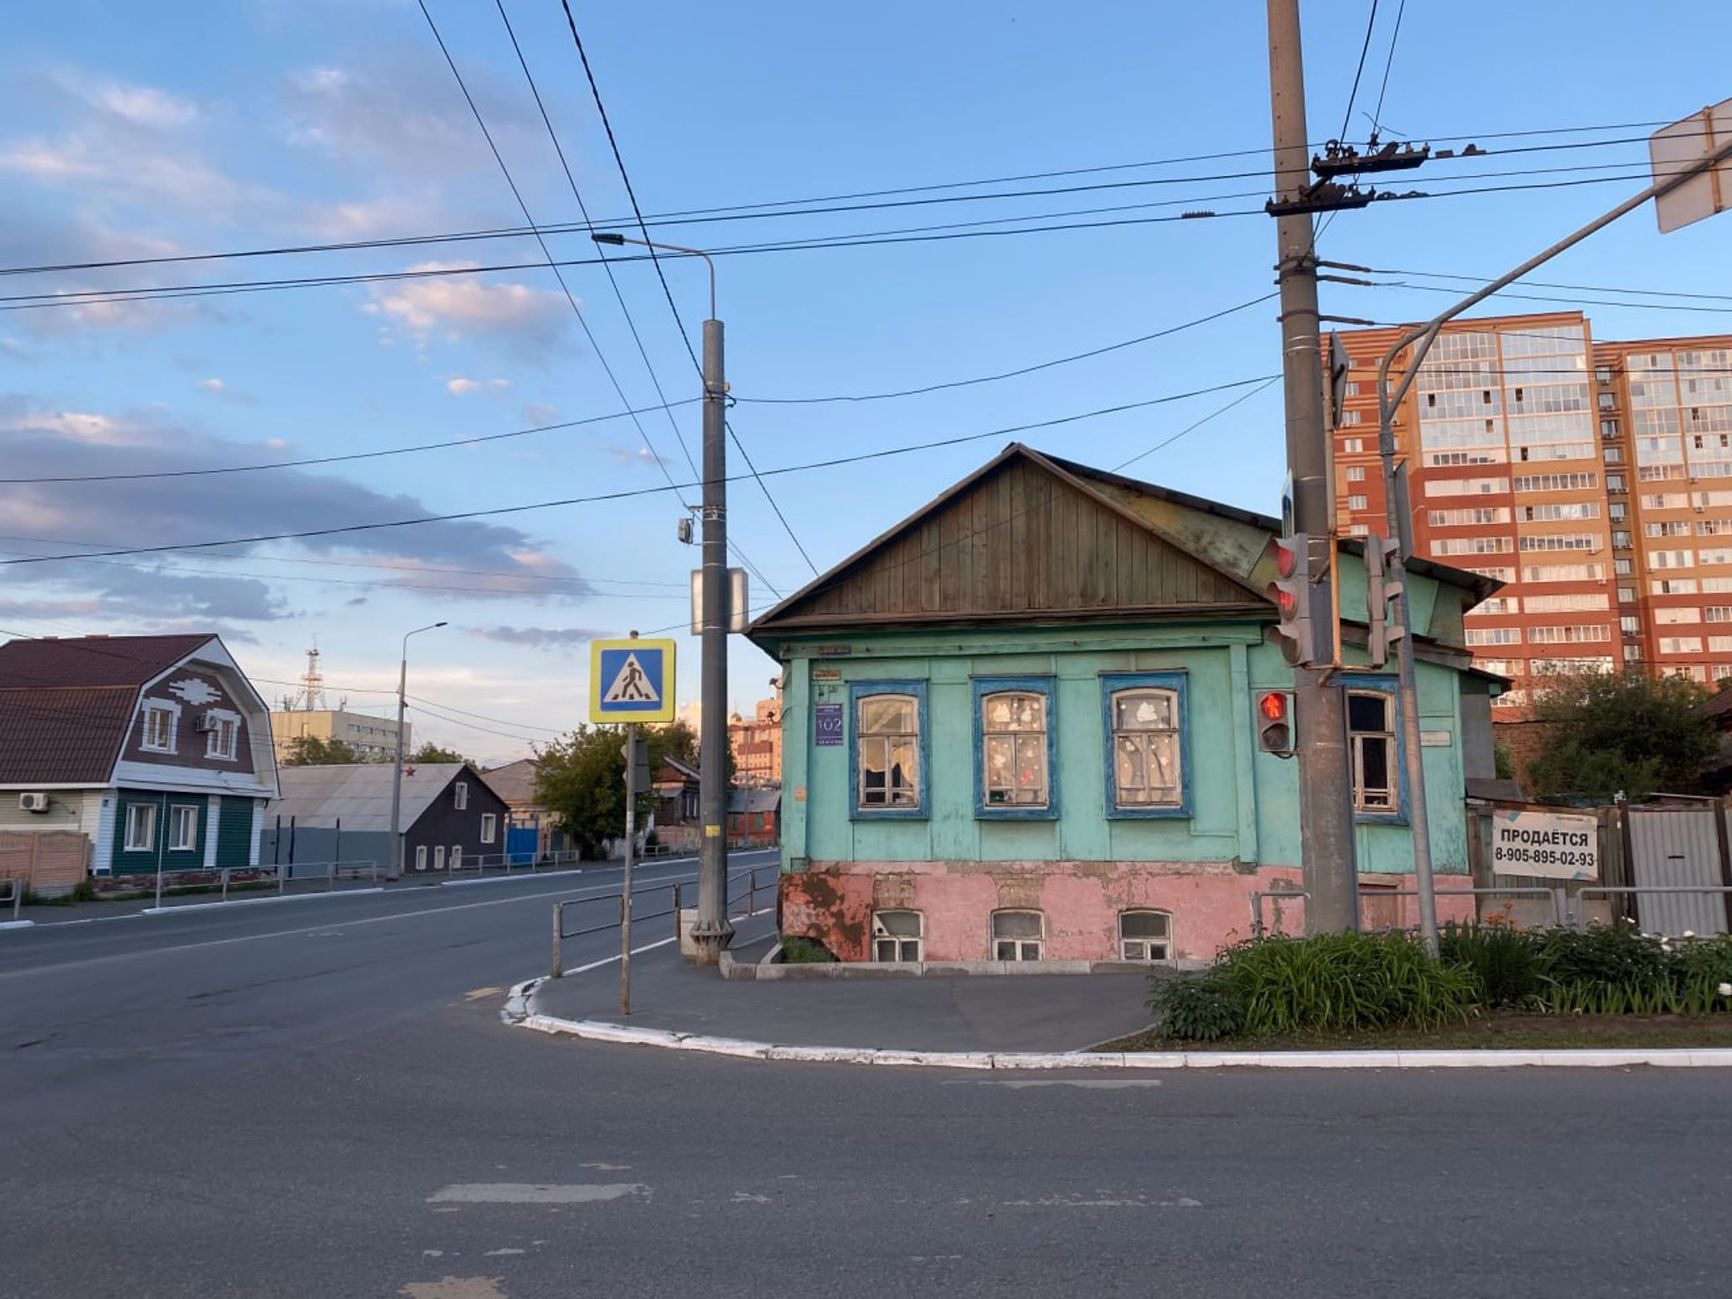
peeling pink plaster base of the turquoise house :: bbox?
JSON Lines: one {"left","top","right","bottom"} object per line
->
{"left": 781, "top": 861, "right": 1474, "bottom": 961}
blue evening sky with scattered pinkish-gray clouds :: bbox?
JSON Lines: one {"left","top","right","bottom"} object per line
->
{"left": 0, "top": 0, "right": 1732, "bottom": 760}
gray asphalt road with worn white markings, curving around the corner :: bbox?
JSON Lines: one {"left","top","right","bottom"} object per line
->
{"left": 0, "top": 845, "right": 1732, "bottom": 1299}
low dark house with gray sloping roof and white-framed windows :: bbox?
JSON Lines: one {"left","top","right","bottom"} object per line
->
{"left": 262, "top": 762, "right": 511, "bottom": 876}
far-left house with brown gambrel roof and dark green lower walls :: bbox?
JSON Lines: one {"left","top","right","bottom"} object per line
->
{"left": 0, "top": 634, "right": 277, "bottom": 894}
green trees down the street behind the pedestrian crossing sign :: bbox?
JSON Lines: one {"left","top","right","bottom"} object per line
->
{"left": 535, "top": 722, "right": 698, "bottom": 857}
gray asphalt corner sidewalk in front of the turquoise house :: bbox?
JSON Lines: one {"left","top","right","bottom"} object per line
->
{"left": 535, "top": 916, "right": 1148, "bottom": 1051}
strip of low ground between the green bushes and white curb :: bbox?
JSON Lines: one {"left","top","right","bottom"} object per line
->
{"left": 1095, "top": 1013, "right": 1732, "bottom": 1051}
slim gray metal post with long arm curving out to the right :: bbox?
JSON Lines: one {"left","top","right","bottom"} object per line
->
{"left": 1371, "top": 127, "right": 1732, "bottom": 953}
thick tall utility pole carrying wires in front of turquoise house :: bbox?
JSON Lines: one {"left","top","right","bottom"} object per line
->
{"left": 1268, "top": 0, "right": 1360, "bottom": 934}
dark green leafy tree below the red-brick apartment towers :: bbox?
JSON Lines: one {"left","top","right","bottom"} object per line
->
{"left": 1528, "top": 672, "right": 1715, "bottom": 802}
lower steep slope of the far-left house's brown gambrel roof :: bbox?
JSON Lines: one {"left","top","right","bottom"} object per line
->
{"left": 0, "top": 685, "right": 139, "bottom": 785}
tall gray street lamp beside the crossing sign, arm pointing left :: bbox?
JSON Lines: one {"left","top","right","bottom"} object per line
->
{"left": 591, "top": 230, "right": 734, "bottom": 965}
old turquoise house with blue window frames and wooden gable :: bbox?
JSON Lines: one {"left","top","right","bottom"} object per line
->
{"left": 746, "top": 443, "right": 1500, "bottom": 961}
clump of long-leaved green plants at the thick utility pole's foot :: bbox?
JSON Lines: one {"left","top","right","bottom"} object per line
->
{"left": 1216, "top": 934, "right": 1476, "bottom": 1036}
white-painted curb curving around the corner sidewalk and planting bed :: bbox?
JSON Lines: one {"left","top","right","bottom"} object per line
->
{"left": 501, "top": 979, "right": 1732, "bottom": 1070}
